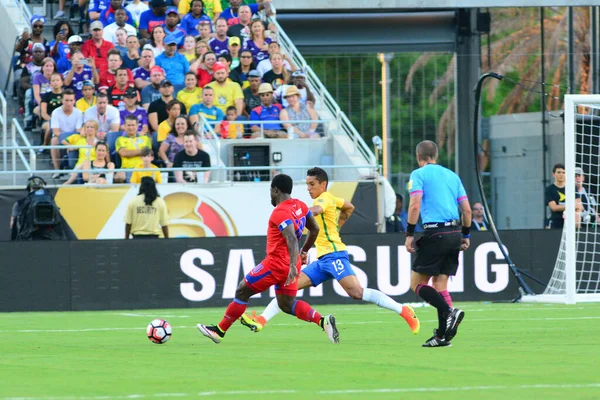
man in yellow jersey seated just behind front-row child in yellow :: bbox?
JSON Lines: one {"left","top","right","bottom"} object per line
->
{"left": 115, "top": 115, "right": 152, "bottom": 183}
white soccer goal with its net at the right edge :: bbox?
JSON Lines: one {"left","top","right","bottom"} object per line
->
{"left": 522, "top": 95, "right": 600, "bottom": 304}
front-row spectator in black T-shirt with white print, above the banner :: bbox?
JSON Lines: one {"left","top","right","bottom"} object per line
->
{"left": 173, "top": 130, "right": 210, "bottom": 183}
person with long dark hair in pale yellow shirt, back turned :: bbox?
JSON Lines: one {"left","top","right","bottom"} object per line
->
{"left": 125, "top": 176, "right": 169, "bottom": 239}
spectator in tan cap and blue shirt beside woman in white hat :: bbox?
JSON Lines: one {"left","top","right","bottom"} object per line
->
{"left": 250, "top": 83, "right": 287, "bottom": 139}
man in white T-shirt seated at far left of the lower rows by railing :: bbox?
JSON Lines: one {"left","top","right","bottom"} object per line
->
{"left": 50, "top": 89, "right": 83, "bottom": 179}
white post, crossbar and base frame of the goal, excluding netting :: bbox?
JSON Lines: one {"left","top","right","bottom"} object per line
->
{"left": 521, "top": 95, "right": 600, "bottom": 304}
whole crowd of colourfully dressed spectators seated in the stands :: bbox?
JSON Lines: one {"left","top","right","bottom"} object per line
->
{"left": 15, "top": 0, "right": 322, "bottom": 184}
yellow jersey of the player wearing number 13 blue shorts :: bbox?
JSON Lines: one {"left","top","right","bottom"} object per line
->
{"left": 313, "top": 192, "right": 346, "bottom": 257}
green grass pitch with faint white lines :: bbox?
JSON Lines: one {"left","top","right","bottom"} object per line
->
{"left": 0, "top": 303, "right": 600, "bottom": 400}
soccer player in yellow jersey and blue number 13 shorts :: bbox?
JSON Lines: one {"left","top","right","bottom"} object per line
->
{"left": 240, "top": 167, "right": 420, "bottom": 335}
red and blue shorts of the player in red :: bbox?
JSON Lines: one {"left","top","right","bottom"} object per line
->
{"left": 244, "top": 257, "right": 302, "bottom": 297}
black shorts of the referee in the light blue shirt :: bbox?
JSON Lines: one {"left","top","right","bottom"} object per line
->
{"left": 412, "top": 226, "right": 462, "bottom": 276}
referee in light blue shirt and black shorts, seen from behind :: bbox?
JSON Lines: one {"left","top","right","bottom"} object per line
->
{"left": 406, "top": 140, "right": 471, "bottom": 347}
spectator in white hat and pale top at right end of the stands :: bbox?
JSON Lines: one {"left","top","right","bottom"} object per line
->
{"left": 279, "top": 85, "right": 321, "bottom": 139}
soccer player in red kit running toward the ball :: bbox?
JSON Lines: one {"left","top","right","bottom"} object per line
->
{"left": 198, "top": 174, "right": 340, "bottom": 343}
